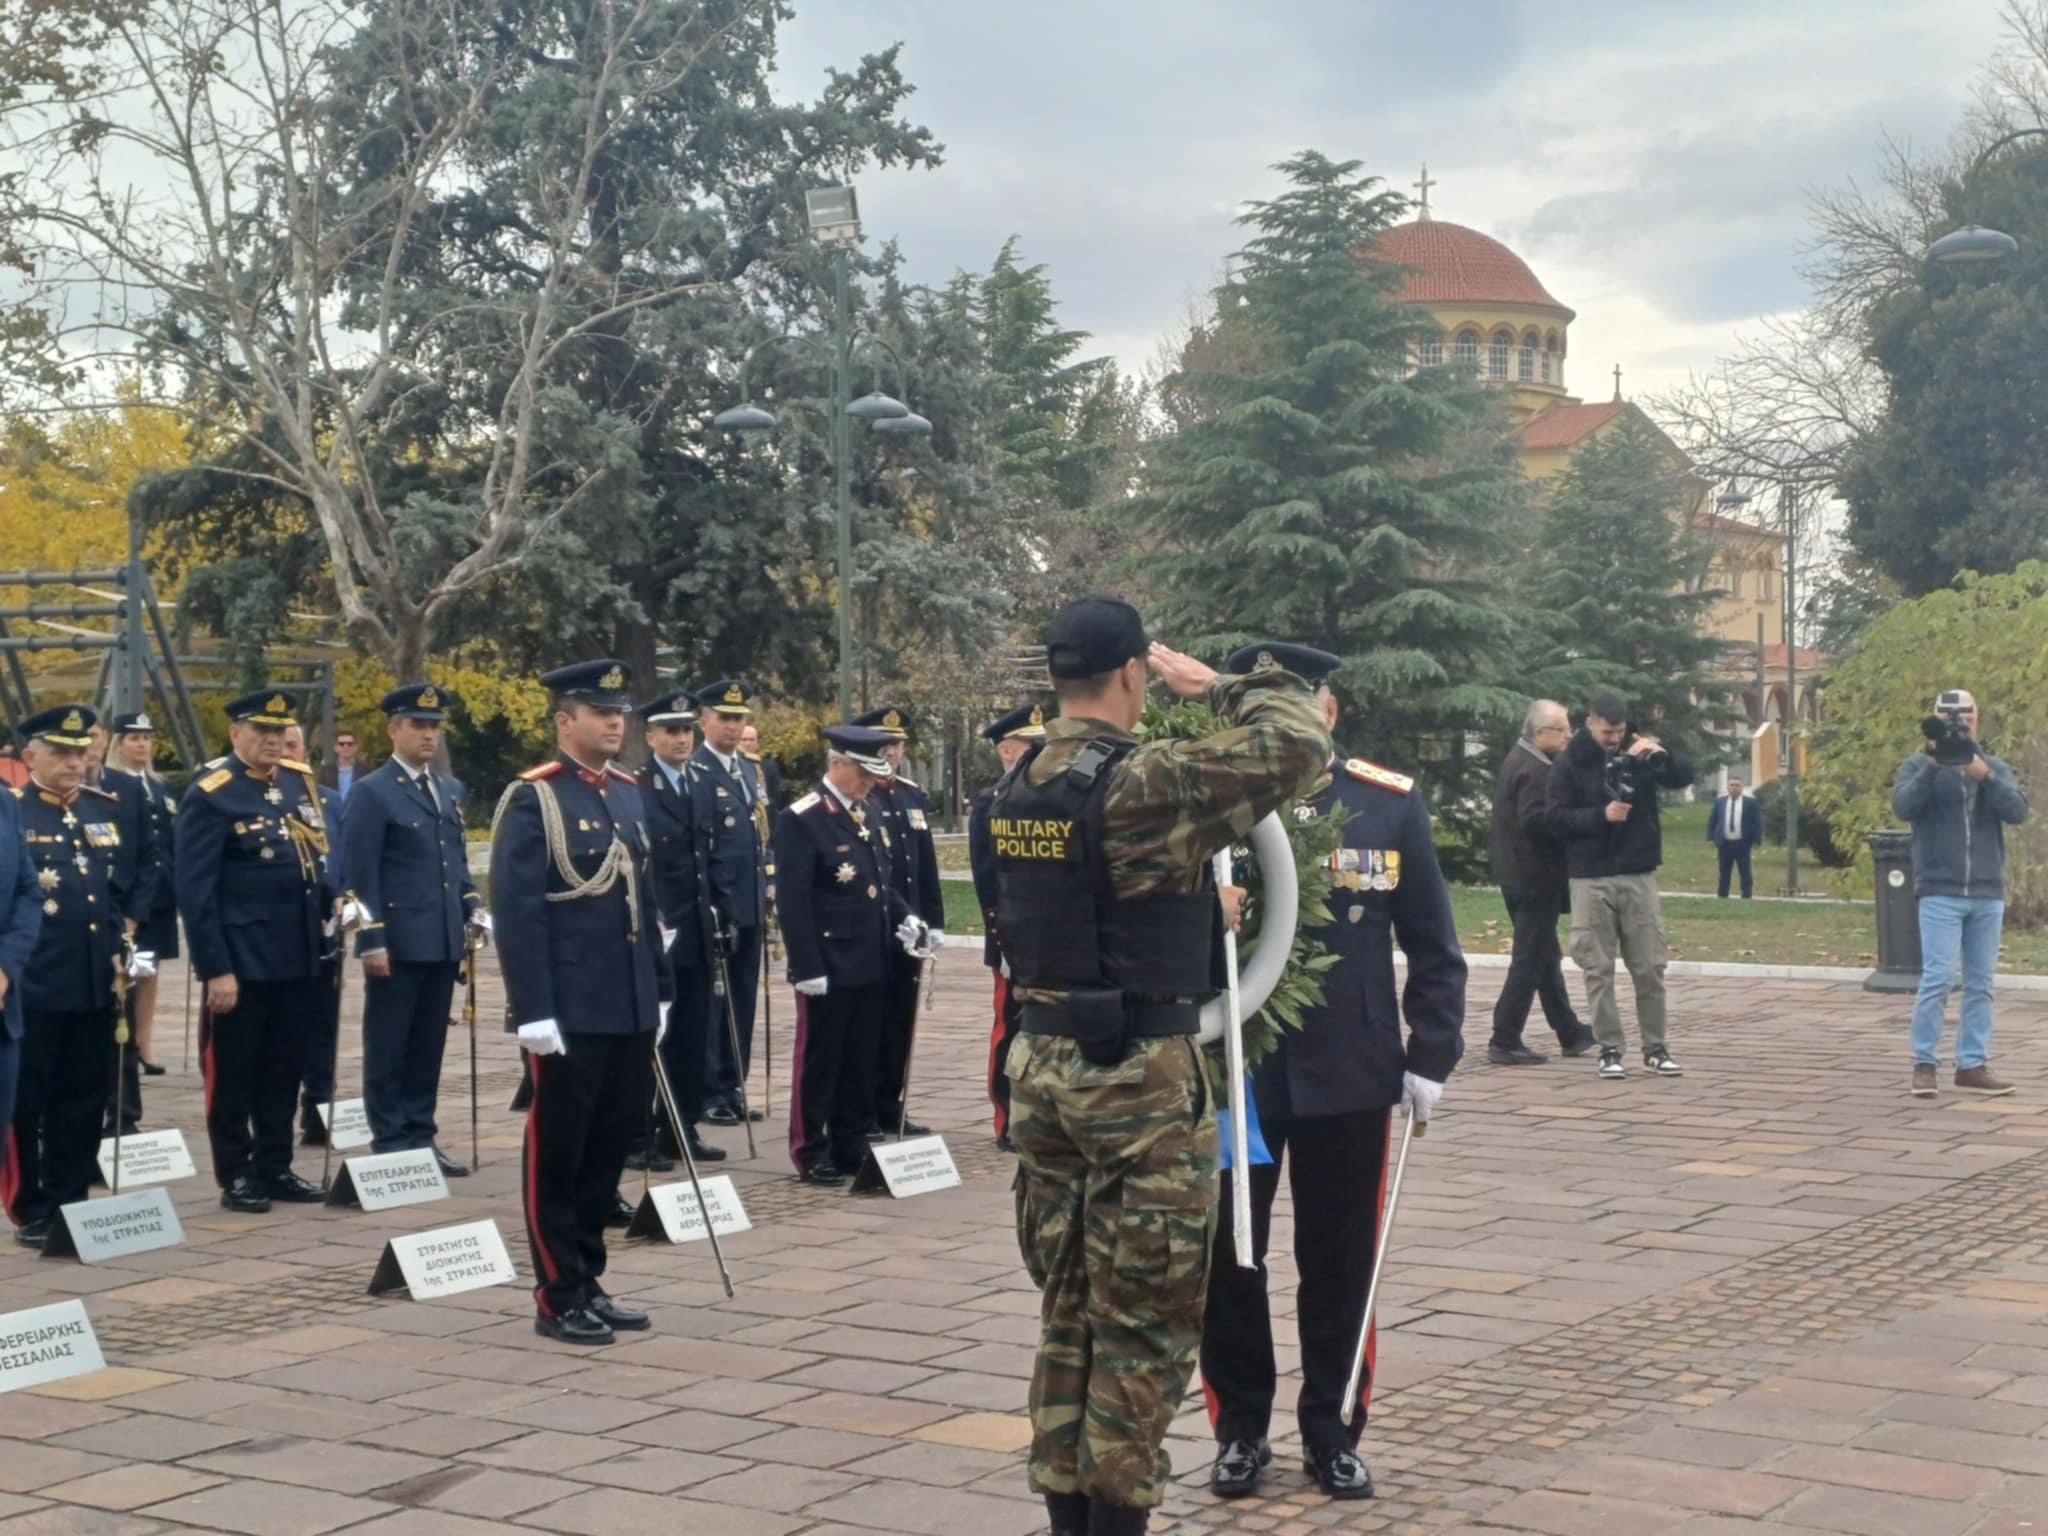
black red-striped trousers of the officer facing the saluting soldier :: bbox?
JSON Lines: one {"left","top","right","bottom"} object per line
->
{"left": 1202, "top": 1110, "right": 1389, "bottom": 1448}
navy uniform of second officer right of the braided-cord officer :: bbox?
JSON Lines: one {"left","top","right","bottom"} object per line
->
{"left": 690, "top": 748, "right": 770, "bottom": 1114}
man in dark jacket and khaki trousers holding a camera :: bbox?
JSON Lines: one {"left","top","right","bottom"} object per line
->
{"left": 1544, "top": 694, "right": 1692, "bottom": 1079}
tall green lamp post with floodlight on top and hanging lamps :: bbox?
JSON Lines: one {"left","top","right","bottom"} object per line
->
{"left": 713, "top": 186, "right": 932, "bottom": 721}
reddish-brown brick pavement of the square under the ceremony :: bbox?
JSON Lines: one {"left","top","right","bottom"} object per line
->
{"left": 0, "top": 952, "right": 2048, "bottom": 1536}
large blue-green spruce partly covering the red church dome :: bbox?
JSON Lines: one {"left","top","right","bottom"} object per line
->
{"left": 1122, "top": 152, "right": 1526, "bottom": 856}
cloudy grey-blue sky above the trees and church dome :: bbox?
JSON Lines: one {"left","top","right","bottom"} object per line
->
{"left": 782, "top": 0, "right": 2001, "bottom": 399}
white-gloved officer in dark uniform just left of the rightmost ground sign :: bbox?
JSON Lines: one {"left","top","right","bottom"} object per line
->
{"left": 774, "top": 725, "right": 928, "bottom": 1186}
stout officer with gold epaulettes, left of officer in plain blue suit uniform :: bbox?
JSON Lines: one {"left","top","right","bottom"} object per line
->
{"left": 176, "top": 688, "right": 334, "bottom": 1212}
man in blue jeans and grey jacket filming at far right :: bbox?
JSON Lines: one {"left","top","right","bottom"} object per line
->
{"left": 1892, "top": 688, "right": 2028, "bottom": 1098}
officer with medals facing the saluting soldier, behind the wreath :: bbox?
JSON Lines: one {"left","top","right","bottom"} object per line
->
{"left": 1202, "top": 645, "right": 1464, "bottom": 1499}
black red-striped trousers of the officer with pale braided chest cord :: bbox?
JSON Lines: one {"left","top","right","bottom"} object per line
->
{"left": 520, "top": 1034, "right": 653, "bottom": 1317}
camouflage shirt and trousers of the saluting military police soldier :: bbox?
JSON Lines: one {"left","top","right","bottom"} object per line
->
{"left": 1006, "top": 668, "right": 1329, "bottom": 1507}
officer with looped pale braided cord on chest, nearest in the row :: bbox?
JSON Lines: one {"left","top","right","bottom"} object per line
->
{"left": 492, "top": 657, "right": 672, "bottom": 1343}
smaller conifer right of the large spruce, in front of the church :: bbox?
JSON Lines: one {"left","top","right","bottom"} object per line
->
{"left": 1526, "top": 414, "right": 1729, "bottom": 756}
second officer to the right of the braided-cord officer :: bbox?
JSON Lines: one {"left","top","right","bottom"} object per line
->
{"left": 690, "top": 678, "right": 774, "bottom": 1124}
